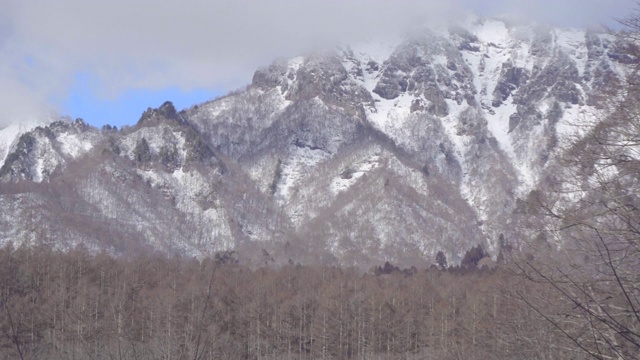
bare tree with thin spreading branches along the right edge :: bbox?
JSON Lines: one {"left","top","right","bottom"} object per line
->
{"left": 516, "top": 8, "right": 640, "bottom": 359}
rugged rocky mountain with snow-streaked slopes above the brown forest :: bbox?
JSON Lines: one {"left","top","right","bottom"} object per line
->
{"left": 0, "top": 18, "right": 628, "bottom": 266}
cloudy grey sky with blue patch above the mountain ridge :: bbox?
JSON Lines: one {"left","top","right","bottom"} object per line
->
{"left": 0, "top": 0, "right": 637, "bottom": 129}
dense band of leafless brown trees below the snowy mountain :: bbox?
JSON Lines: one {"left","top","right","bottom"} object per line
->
{"left": 0, "top": 245, "right": 576, "bottom": 359}
